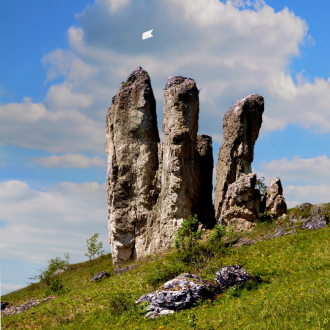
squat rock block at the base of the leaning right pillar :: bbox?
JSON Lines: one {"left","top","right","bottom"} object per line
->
{"left": 219, "top": 173, "right": 261, "bottom": 232}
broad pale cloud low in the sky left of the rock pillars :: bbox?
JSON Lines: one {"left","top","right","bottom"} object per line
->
{"left": 0, "top": 181, "right": 109, "bottom": 265}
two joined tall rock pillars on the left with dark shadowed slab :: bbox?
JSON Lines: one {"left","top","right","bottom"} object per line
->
{"left": 106, "top": 67, "right": 214, "bottom": 266}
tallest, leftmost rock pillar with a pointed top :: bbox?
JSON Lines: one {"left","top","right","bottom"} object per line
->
{"left": 105, "top": 67, "right": 160, "bottom": 265}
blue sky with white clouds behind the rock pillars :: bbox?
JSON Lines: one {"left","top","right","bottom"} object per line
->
{"left": 0, "top": 0, "right": 330, "bottom": 294}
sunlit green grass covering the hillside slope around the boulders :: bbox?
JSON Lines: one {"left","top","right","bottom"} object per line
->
{"left": 2, "top": 214, "right": 330, "bottom": 330}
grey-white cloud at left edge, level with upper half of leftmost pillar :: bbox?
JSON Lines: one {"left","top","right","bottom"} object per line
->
{"left": 0, "top": 98, "right": 105, "bottom": 153}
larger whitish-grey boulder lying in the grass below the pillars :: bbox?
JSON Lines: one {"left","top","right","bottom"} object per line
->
{"left": 136, "top": 273, "right": 217, "bottom": 318}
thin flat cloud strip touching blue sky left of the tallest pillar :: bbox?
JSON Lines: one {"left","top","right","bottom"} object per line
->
{"left": 31, "top": 154, "right": 105, "bottom": 168}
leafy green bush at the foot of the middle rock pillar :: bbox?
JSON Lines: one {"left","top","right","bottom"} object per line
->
{"left": 174, "top": 214, "right": 202, "bottom": 250}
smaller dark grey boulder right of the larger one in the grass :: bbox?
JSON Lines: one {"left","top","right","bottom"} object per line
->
{"left": 214, "top": 265, "right": 252, "bottom": 290}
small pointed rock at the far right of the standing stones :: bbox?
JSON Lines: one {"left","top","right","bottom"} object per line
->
{"left": 265, "top": 178, "right": 287, "bottom": 217}
